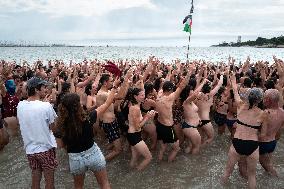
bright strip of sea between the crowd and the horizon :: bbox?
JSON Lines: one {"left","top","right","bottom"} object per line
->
{"left": 0, "top": 46, "right": 284, "bottom": 63}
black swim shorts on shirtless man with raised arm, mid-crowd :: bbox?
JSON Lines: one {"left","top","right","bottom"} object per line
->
{"left": 156, "top": 122, "right": 178, "bottom": 144}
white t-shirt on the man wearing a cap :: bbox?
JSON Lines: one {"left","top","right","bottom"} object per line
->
{"left": 17, "top": 100, "right": 57, "bottom": 154}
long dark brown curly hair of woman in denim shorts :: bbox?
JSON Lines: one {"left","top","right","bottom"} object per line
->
{"left": 58, "top": 93, "right": 86, "bottom": 140}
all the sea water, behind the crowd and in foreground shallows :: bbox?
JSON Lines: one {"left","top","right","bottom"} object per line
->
{"left": 0, "top": 47, "right": 284, "bottom": 189}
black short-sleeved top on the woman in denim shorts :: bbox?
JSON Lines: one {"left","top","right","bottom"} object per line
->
{"left": 62, "top": 110, "right": 97, "bottom": 153}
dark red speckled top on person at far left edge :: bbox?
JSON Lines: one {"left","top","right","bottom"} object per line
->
{"left": 2, "top": 93, "right": 19, "bottom": 118}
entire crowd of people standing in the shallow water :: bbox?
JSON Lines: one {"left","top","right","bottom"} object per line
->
{"left": 0, "top": 57, "right": 284, "bottom": 188}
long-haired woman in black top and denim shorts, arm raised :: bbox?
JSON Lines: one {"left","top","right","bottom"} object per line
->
{"left": 58, "top": 82, "right": 117, "bottom": 189}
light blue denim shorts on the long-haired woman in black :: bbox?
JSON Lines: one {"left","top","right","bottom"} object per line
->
{"left": 68, "top": 143, "right": 106, "bottom": 175}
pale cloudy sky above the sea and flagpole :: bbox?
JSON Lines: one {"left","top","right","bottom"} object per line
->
{"left": 0, "top": 0, "right": 284, "bottom": 47}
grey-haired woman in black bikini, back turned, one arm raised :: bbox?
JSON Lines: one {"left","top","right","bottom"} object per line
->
{"left": 222, "top": 75, "right": 263, "bottom": 188}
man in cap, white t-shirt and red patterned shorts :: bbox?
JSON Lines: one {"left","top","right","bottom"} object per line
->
{"left": 17, "top": 77, "right": 58, "bottom": 189}
